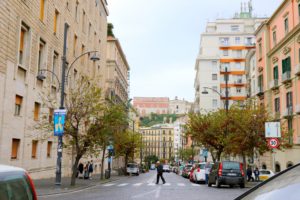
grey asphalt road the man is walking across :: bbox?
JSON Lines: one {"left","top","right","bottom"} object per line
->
{"left": 39, "top": 171, "right": 248, "bottom": 200}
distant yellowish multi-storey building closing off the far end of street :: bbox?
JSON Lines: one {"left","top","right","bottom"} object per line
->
{"left": 139, "top": 124, "right": 175, "bottom": 160}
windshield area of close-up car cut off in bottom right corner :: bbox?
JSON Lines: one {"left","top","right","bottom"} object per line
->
{"left": 236, "top": 165, "right": 300, "bottom": 200}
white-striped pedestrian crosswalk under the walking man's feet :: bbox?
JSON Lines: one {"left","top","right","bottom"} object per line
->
{"left": 102, "top": 183, "right": 201, "bottom": 187}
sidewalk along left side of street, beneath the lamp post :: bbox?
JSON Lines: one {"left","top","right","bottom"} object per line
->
{"left": 33, "top": 174, "right": 127, "bottom": 196}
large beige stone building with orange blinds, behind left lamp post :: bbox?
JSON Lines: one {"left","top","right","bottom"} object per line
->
{"left": 0, "top": 0, "right": 108, "bottom": 178}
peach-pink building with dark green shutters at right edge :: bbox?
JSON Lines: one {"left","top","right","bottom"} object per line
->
{"left": 255, "top": 0, "right": 300, "bottom": 172}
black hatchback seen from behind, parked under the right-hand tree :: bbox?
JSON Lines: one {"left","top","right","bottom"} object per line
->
{"left": 208, "top": 161, "right": 245, "bottom": 188}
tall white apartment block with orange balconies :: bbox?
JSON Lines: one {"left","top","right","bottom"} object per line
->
{"left": 194, "top": 1, "right": 265, "bottom": 113}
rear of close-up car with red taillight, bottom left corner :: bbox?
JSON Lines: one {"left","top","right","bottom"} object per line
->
{"left": 0, "top": 165, "right": 37, "bottom": 200}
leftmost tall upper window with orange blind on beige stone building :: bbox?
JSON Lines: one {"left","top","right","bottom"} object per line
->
{"left": 19, "top": 22, "right": 29, "bottom": 65}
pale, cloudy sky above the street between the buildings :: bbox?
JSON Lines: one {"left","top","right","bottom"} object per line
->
{"left": 108, "top": 0, "right": 283, "bottom": 102}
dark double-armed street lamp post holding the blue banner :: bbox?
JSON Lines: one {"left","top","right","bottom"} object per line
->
{"left": 37, "top": 23, "right": 100, "bottom": 185}
